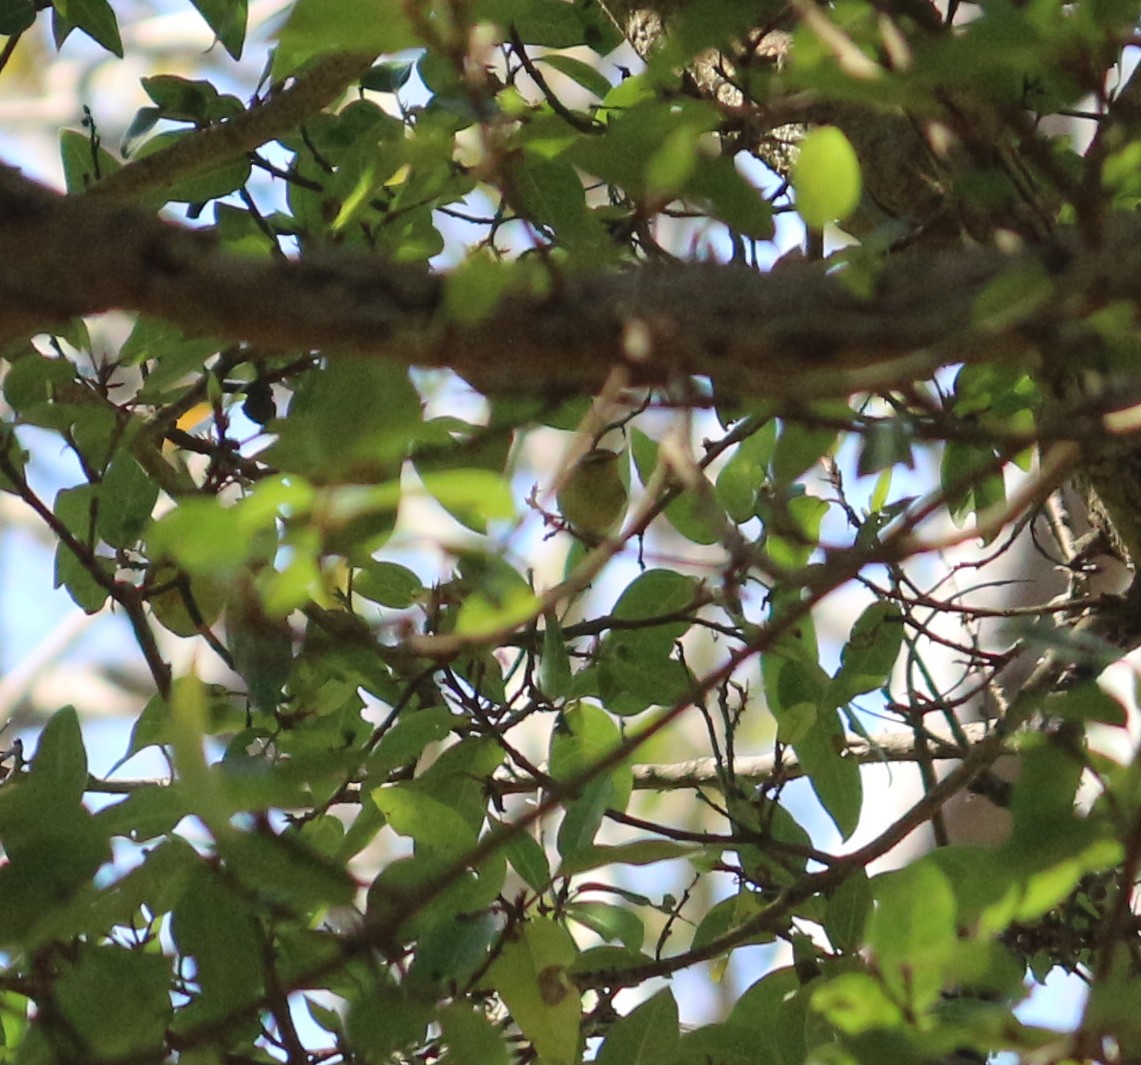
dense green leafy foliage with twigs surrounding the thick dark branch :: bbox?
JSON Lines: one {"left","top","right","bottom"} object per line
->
{"left": 0, "top": 0, "right": 1141, "bottom": 1065}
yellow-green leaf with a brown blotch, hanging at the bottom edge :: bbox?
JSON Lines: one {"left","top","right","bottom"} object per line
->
{"left": 487, "top": 918, "right": 581, "bottom": 1065}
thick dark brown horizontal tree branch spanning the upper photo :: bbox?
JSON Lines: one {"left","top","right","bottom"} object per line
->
{"left": 0, "top": 164, "right": 1122, "bottom": 398}
